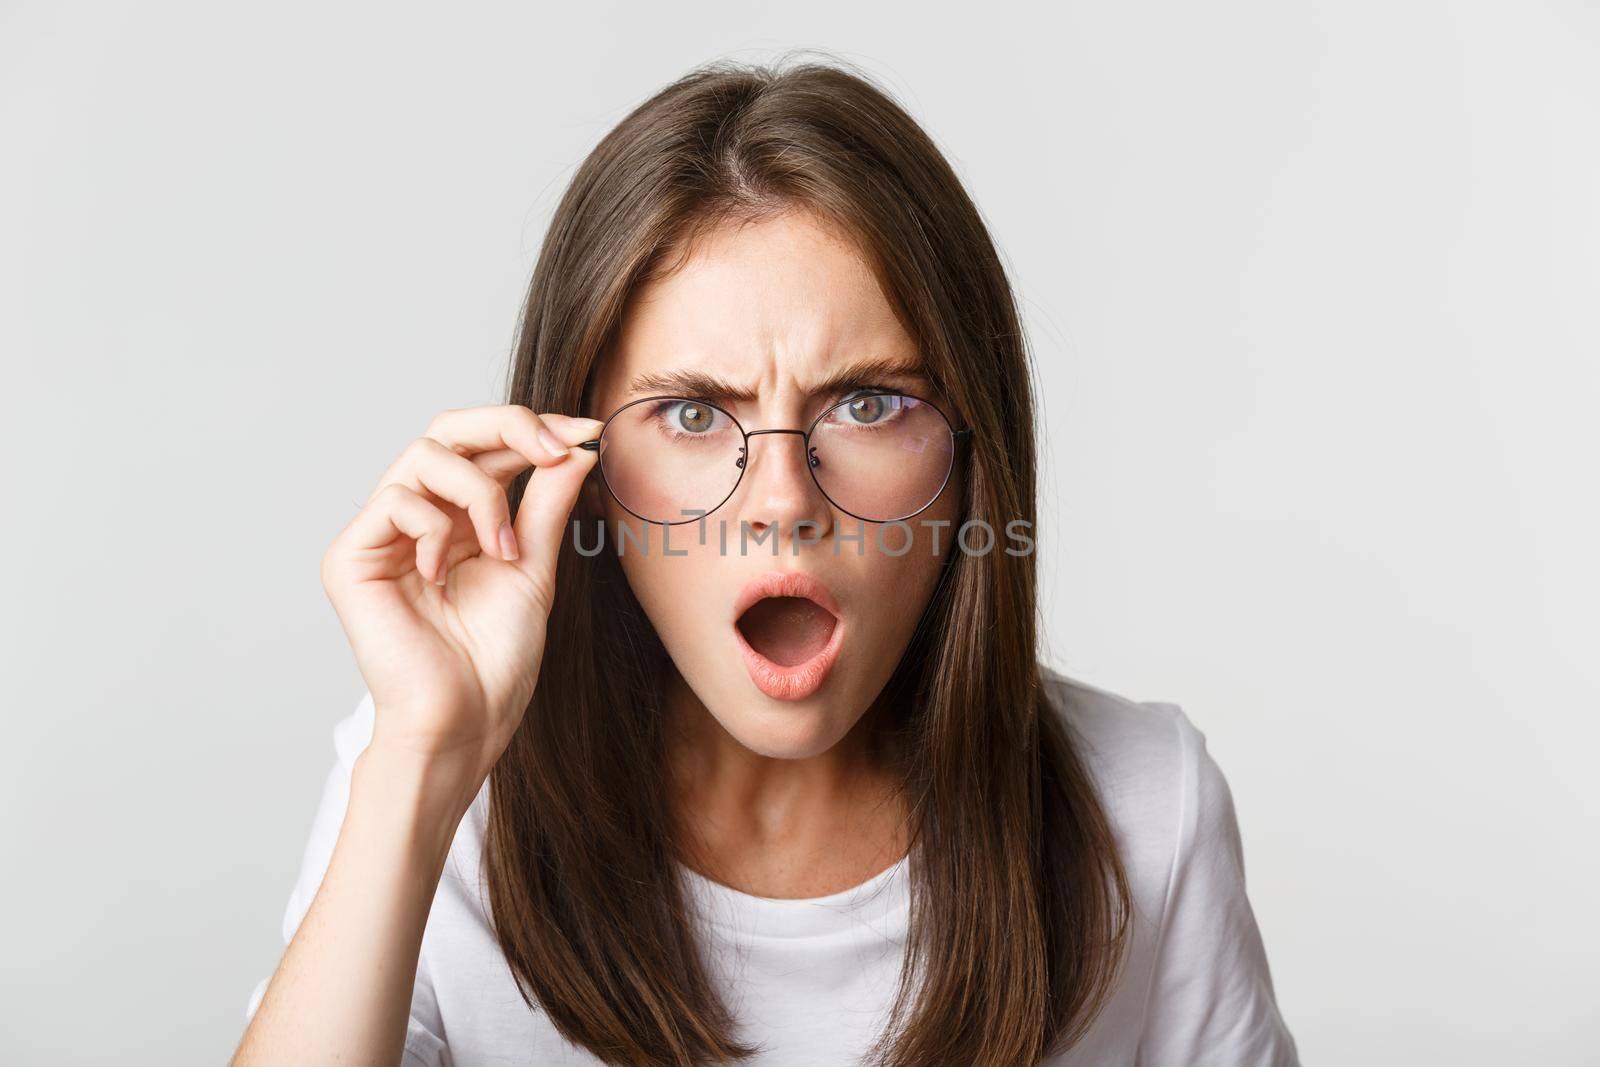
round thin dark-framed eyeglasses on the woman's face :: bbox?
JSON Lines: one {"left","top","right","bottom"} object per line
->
{"left": 579, "top": 390, "right": 971, "bottom": 526}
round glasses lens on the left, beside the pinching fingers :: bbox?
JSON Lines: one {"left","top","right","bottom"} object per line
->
{"left": 600, "top": 397, "right": 744, "bottom": 523}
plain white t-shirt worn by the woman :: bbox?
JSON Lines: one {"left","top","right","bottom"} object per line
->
{"left": 246, "top": 672, "right": 1299, "bottom": 1067}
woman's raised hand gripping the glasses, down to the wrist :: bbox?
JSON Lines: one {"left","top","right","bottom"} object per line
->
{"left": 322, "top": 405, "right": 602, "bottom": 801}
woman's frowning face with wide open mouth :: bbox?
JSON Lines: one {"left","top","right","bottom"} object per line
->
{"left": 584, "top": 213, "right": 962, "bottom": 758}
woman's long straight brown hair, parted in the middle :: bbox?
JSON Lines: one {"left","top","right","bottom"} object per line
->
{"left": 485, "top": 53, "right": 1130, "bottom": 1067}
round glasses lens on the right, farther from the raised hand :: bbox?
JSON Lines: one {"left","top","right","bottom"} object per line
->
{"left": 811, "top": 394, "right": 955, "bottom": 523}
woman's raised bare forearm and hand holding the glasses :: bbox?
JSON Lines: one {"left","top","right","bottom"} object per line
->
{"left": 234, "top": 405, "right": 600, "bottom": 1065}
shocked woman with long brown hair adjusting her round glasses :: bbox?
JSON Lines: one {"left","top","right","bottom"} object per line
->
{"left": 235, "top": 62, "right": 1296, "bottom": 1065}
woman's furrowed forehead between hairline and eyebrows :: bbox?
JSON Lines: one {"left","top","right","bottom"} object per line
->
{"left": 595, "top": 213, "right": 922, "bottom": 406}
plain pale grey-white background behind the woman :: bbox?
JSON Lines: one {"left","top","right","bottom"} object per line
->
{"left": 0, "top": 0, "right": 1600, "bottom": 1067}
